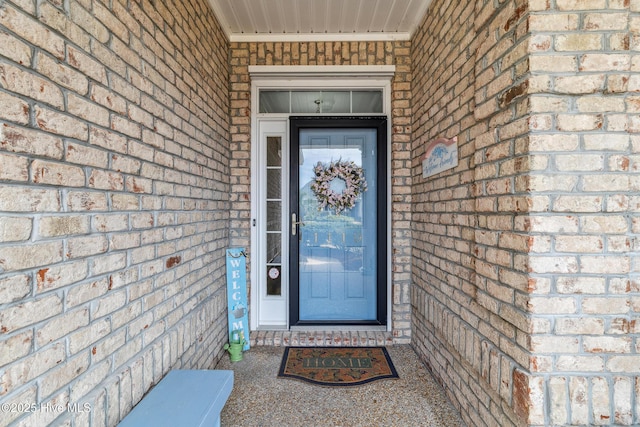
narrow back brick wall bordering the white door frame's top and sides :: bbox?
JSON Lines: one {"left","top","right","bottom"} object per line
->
{"left": 230, "top": 42, "right": 411, "bottom": 343}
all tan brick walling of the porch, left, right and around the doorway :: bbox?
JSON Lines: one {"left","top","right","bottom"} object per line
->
{"left": 0, "top": 0, "right": 640, "bottom": 426}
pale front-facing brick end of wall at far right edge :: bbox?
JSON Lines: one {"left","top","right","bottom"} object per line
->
{"left": 520, "top": 0, "right": 640, "bottom": 425}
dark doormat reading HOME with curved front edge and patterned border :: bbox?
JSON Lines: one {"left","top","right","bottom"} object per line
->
{"left": 278, "top": 347, "right": 398, "bottom": 386}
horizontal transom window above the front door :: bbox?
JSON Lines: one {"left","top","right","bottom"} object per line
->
{"left": 259, "top": 89, "right": 383, "bottom": 114}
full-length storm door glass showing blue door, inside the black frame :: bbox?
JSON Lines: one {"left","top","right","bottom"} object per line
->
{"left": 297, "top": 129, "right": 378, "bottom": 321}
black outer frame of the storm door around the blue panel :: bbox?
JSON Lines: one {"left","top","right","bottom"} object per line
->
{"left": 287, "top": 116, "right": 389, "bottom": 326}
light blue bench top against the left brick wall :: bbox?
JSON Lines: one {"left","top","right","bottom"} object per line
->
{"left": 118, "top": 370, "right": 233, "bottom": 427}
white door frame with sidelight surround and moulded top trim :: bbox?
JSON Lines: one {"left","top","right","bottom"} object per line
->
{"left": 249, "top": 65, "right": 395, "bottom": 331}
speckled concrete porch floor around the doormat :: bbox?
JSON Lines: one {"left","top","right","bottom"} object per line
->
{"left": 216, "top": 346, "right": 464, "bottom": 427}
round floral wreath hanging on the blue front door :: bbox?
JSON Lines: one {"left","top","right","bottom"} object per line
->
{"left": 311, "top": 160, "right": 367, "bottom": 215}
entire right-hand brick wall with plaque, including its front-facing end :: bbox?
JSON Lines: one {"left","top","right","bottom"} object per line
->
{"left": 412, "top": 0, "right": 640, "bottom": 426}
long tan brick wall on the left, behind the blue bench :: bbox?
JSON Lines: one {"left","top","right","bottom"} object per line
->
{"left": 0, "top": 0, "right": 230, "bottom": 426}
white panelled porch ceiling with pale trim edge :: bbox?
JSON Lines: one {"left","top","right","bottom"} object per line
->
{"left": 209, "top": 0, "right": 432, "bottom": 41}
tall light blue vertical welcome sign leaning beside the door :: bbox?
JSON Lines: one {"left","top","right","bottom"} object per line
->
{"left": 227, "top": 248, "right": 249, "bottom": 351}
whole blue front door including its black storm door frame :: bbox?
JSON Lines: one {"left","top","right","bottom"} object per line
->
{"left": 289, "top": 117, "right": 387, "bottom": 326}
